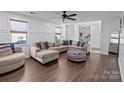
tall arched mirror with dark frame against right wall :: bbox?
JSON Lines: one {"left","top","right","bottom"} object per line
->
{"left": 109, "top": 31, "right": 120, "bottom": 55}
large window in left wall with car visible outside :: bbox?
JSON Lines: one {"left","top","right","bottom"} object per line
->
{"left": 10, "top": 19, "right": 28, "bottom": 44}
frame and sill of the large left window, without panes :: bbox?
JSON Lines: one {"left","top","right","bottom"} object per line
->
{"left": 9, "top": 19, "right": 29, "bottom": 45}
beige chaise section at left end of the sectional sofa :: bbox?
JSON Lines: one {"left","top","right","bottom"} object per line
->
{"left": 30, "top": 46, "right": 59, "bottom": 64}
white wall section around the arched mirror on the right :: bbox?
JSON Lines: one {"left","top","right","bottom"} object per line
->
{"left": 101, "top": 18, "right": 120, "bottom": 55}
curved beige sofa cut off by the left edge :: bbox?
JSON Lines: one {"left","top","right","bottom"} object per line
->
{"left": 0, "top": 48, "right": 25, "bottom": 74}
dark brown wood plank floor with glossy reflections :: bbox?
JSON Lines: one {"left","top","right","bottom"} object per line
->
{"left": 0, "top": 53, "right": 121, "bottom": 82}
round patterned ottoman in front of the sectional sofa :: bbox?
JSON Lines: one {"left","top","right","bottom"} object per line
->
{"left": 67, "top": 49, "right": 86, "bottom": 61}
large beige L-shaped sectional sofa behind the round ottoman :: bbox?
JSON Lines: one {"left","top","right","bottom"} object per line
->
{"left": 30, "top": 41, "right": 89, "bottom": 64}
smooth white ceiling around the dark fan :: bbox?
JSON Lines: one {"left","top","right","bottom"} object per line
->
{"left": 10, "top": 11, "right": 121, "bottom": 22}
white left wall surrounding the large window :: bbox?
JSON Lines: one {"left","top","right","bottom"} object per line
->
{"left": 0, "top": 12, "right": 56, "bottom": 57}
